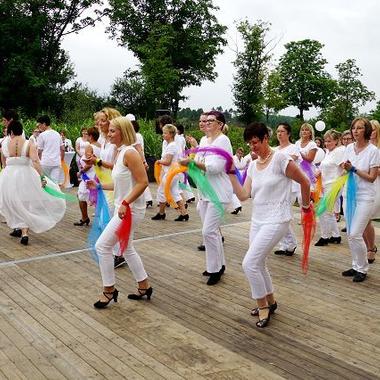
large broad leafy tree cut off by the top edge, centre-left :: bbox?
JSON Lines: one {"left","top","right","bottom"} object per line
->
{"left": 109, "top": 0, "right": 226, "bottom": 114}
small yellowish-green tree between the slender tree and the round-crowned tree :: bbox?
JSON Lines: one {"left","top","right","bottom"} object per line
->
{"left": 264, "top": 70, "right": 287, "bottom": 123}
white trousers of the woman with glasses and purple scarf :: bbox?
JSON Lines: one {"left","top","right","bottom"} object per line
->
{"left": 198, "top": 200, "right": 227, "bottom": 273}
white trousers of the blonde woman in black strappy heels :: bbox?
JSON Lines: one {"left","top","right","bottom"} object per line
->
{"left": 95, "top": 212, "right": 148, "bottom": 286}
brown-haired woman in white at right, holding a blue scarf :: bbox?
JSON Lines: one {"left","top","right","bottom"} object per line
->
{"left": 342, "top": 117, "right": 380, "bottom": 282}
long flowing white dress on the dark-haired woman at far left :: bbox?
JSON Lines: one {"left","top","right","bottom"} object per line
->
{"left": 0, "top": 141, "right": 66, "bottom": 233}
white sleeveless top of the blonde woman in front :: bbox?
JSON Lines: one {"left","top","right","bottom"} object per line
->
{"left": 112, "top": 145, "right": 146, "bottom": 213}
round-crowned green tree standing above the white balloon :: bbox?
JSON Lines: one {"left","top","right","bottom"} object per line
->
{"left": 278, "top": 39, "right": 334, "bottom": 120}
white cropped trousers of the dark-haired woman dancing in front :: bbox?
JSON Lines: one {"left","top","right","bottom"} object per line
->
{"left": 242, "top": 222, "right": 290, "bottom": 299}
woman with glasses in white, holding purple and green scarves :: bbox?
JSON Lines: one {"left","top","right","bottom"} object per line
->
{"left": 180, "top": 111, "right": 232, "bottom": 285}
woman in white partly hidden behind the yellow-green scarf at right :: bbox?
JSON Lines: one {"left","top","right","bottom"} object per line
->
{"left": 314, "top": 129, "right": 346, "bottom": 247}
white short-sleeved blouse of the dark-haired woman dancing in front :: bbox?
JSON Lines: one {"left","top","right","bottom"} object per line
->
{"left": 247, "top": 150, "right": 292, "bottom": 224}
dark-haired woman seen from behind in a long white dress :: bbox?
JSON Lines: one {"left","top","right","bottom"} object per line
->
{"left": 0, "top": 121, "right": 66, "bottom": 245}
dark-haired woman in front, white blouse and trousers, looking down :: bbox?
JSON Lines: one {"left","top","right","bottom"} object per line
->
{"left": 230, "top": 122, "right": 311, "bottom": 328}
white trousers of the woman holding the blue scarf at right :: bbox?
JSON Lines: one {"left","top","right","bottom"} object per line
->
{"left": 343, "top": 199, "right": 374, "bottom": 273}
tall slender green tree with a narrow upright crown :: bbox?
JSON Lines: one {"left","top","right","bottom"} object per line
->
{"left": 233, "top": 20, "right": 271, "bottom": 123}
